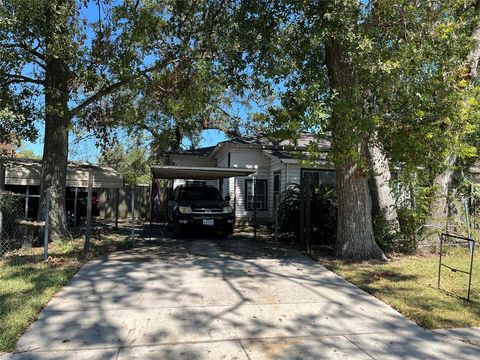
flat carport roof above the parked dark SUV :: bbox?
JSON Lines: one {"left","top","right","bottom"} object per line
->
{"left": 151, "top": 165, "right": 256, "bottom": 180}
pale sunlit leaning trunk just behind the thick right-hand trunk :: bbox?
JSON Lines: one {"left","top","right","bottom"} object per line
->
{"left": 368, "top": 133, "right": 400, "bottom": 236}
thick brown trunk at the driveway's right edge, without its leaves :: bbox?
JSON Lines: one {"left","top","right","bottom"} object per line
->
{"left": 325, "top": 40, "right": 385, "bottom": 261}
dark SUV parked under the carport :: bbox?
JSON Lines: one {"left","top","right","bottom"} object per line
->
{"left": 168, "top": 185, "right": 235, "bottom": 237}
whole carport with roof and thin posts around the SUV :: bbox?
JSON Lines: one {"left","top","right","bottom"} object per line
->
{"left": 150, "top": 165, "right": 257, "bottom": 238}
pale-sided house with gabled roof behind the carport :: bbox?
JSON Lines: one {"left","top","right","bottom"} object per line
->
{"left": 165, "top": 134, "right": 335, "bottom": 223}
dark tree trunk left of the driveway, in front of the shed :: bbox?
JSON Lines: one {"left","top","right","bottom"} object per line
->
{"left": 40, "top": 57, "right": 70, "bottom": 240}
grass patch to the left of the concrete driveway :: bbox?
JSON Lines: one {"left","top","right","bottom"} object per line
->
{"left": 0, "top": 233, "right": 131, "bottom": 353}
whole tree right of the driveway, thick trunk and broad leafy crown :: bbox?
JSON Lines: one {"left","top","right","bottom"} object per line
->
{"left": 235, "top": 0, "right": 480, "bottom": 260}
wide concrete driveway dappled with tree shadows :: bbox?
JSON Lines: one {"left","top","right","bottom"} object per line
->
{"left": 6, "top": 232, "right": 480, "bottom": 360}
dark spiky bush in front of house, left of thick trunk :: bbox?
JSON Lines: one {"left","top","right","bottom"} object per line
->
{"left": 278, "top": 184, "right": 337, "bottom": 245}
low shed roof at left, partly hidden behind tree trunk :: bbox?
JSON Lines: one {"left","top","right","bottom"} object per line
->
{"left": 1, "top": 159, "right": 123, "bottom": 189}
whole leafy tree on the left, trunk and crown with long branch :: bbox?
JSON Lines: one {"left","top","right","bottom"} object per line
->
{"left": 0, "top": 0, "right": 240, "bottom": 238}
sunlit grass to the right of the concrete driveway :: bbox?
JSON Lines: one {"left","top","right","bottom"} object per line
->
{"left": 318, "top": 248, "right": 480, "bottom": 329}
